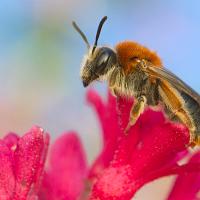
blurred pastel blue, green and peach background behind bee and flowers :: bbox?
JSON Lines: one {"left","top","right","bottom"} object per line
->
{"left": 0, "top": 0, "right": 200, "bottom": 200}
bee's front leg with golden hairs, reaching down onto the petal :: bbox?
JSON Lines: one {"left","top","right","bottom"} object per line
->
{"left": 125, "top": 96, "right": 146, "bottom": 134}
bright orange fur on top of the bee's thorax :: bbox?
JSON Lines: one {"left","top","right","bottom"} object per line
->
{"left": 115, "top": 41, "right": 162, "bottom": 72}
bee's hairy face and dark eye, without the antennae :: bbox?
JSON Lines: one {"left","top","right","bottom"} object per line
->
{"left": 81, "top": 47, "right": 117, "bottom": 87}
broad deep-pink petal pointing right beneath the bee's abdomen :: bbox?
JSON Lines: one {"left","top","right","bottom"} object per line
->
{"left": 131, "top": 123, "right": 190, "bottom": 177}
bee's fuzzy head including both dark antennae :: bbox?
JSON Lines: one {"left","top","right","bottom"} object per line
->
{"left": 73, "top": 16, "right": 117, "bottom": 87}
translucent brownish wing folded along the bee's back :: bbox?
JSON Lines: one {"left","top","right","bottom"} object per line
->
{"left": 145, "top": 66, "right": 200, "bottom": 103}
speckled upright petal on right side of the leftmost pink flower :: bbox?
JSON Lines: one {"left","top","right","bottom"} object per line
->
{"left": 14, "top": 127, "right": 46, "bottom": 200}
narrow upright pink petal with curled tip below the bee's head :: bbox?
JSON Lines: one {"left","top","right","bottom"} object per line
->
{"left": 87, "top": 90, "right": 120, "bottom": 179}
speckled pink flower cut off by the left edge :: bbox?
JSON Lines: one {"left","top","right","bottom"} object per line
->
{"left": 0, "top": 127, "right": 49, "bottom": 200}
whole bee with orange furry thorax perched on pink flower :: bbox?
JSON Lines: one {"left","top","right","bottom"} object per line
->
{"left": 73, "top": 16, "right": 200, "bottom": 146}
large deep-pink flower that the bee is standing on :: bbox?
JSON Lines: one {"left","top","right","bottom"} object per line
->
{"left": 88, "top": 91, "right": 200, "bottom": 200}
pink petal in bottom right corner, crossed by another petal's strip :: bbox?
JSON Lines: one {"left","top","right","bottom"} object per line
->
{"left": 167, "top": 152, "right": 200, "bottom": 200}
